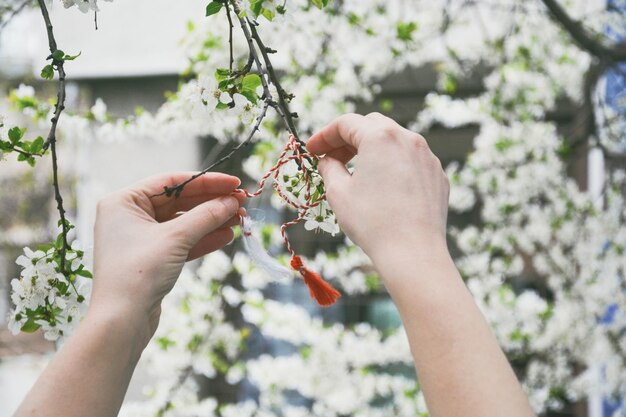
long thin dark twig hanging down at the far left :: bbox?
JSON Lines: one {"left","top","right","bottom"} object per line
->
{"left": 37, "top": 0, "right": 69, "bottom": 276}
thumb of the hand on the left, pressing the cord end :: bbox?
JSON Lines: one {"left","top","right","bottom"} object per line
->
{"left": 171, "top": 196, "right": 239, "bottom": 248}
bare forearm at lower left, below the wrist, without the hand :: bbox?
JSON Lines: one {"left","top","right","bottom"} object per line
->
{"left": 15, "top": 302, "right": 147, "bottom": 417}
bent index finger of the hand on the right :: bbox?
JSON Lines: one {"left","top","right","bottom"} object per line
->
{"left": 306, "top": 113, "right": 374, "bottom": 155}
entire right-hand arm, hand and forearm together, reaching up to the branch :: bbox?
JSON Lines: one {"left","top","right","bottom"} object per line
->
{"left": 307, "top": 113, "right": 534, "bottom": 417}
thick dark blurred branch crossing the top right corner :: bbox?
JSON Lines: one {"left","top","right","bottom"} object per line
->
{"left": 542, "top": 0, "right": 626, "bottom": 62}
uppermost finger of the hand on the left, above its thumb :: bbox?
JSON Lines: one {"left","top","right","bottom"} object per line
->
{"left": 129, "top": 171, "right": 241, "bottom": 207}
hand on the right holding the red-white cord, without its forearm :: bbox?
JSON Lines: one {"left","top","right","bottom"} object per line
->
{"left": 307, "top": 113, "right": 449, "bottom": 260}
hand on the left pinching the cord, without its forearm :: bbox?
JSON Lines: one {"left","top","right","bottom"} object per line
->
{"left": 88, "top": 172, "right": 244, "bottom": 346}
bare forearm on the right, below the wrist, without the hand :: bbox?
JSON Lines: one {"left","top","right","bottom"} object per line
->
{"left": 370, "top": 244, "right": 534, "bottom": 417}
